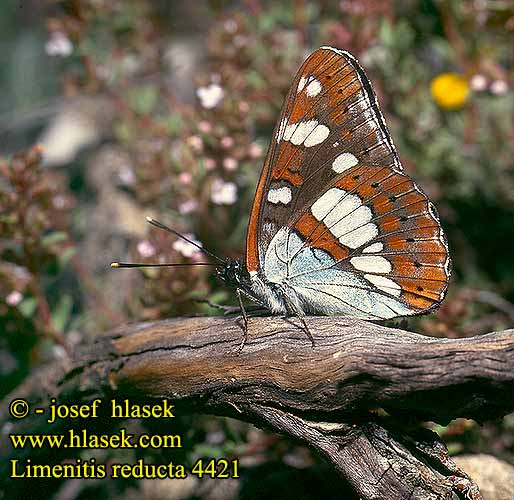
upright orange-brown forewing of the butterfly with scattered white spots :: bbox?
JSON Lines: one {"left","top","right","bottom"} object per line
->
{"left": 247, "top": 48, "right": 402, "bottom": 270}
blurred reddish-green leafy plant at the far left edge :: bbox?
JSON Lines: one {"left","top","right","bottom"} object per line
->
{"left": 0, "top": 147, "right": 75, "bottom": 391}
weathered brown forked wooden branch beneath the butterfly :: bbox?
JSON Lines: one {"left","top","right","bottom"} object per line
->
{"left": 0, "top": 317, "right": 514, "bottom": 500}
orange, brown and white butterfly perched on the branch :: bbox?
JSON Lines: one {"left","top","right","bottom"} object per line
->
{"left": 112, "top": 47, "right": 451, "bottom": 341}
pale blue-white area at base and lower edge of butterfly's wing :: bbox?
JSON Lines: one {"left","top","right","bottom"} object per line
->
{"left": 264, "top": 228, "right": 417, "bottom": 319}
